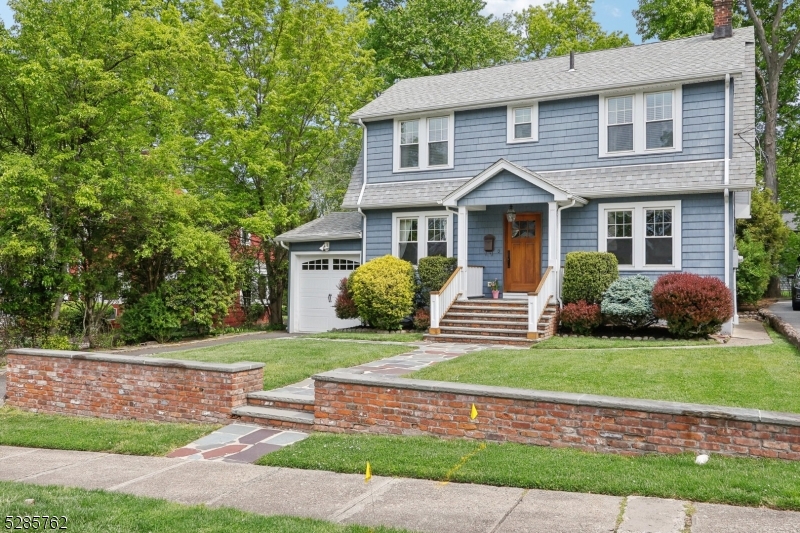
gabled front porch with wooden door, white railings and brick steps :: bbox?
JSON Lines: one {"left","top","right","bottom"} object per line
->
{"left": 430, "top": 159, "right": 586, "bottom": 344}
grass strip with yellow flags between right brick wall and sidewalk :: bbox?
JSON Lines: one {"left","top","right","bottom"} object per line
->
{"left": 258, "top": 434, "right": 800, "bottom": 510}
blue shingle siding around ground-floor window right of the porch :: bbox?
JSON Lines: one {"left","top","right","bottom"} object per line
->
{"left": 561, "top": 194, "right": 725, "bottom": 280}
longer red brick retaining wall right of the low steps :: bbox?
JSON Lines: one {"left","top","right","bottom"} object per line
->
{"left": 314, "top": 371, "right": 800, "bottom": 460}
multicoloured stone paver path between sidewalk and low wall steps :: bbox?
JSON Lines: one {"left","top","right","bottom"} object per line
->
{"left": 167, "top": 424, "right": 308, "bottom": 463}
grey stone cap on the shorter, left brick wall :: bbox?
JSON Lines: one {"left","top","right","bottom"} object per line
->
{"left": 6, "top": 348, "right": 264, "bottom": 373}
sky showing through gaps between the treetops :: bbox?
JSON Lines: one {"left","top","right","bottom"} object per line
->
{"left": 0, "top": 0, "right": 641, "bottom": 43}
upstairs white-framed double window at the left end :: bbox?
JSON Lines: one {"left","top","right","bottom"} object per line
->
{"left": 394, "top": 114, "right": 453, "bottom": 172}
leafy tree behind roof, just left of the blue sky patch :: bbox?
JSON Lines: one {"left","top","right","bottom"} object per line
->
{"left": 514, "top": 0, "right": 633, "bottom": 59}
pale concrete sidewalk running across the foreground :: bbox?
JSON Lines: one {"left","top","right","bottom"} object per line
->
{"left": 0, "top": 446, "right": 800, "bottom": 533}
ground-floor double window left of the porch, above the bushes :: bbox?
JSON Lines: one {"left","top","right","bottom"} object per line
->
{"left": 392, "top": 211, "right": 453, "bottom": 265}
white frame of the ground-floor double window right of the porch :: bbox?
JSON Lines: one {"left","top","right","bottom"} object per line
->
{"left": 597, "top": 200, "right": 682, "bottom": 272}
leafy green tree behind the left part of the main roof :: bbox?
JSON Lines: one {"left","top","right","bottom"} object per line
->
{"left": 364, "top": 0, "right": 517, "bottom": 85}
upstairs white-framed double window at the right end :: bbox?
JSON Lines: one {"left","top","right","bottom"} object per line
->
{"left": 599, "top": 87, "right": 683, "bottom": 157}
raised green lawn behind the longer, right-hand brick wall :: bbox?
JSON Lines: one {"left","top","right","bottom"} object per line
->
{"left": 408, "top": 332, "right": 800, "bottom": 413}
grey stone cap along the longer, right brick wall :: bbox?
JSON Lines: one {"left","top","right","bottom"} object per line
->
{"left": 312, "top": 370, "right": 800, "bottom": 426}
